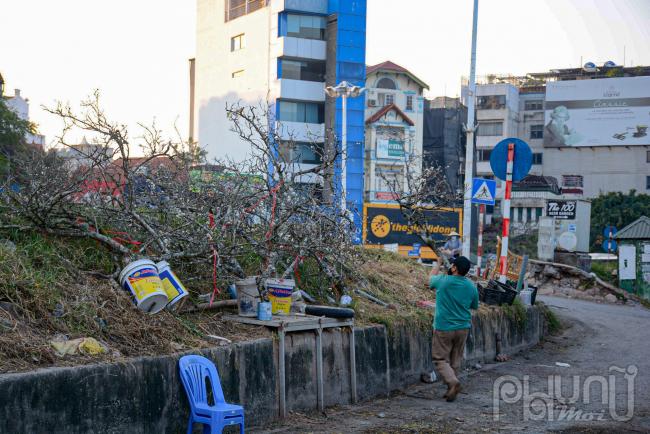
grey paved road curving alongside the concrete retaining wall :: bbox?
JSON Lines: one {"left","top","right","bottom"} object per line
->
{"left": 252, "top": 297, "right": 650, "bottom": 434}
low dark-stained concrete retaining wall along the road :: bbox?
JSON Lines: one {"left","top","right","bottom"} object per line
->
{"left": 0, "top": 308, "right": 545, "bottom": 434}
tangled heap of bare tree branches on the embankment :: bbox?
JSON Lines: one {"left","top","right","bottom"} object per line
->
{"left": 0, "top": 93, "right": 360, "bottom": 298}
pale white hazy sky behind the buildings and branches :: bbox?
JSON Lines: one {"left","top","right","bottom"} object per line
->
{"left": 0, "top": 0, "right": 650, "bottom": 145}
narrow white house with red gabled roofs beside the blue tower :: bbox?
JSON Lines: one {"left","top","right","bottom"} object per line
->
{"left": 364, "top": 61, "right": 429, "bottom": 202}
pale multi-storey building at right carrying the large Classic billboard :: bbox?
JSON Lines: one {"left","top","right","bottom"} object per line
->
{"left": 462, "top": 62, "right": 650, "bottom": 221}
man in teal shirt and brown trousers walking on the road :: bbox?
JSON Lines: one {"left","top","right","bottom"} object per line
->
{"left": 429, "top": 256, "right": 478, "bottom": 402}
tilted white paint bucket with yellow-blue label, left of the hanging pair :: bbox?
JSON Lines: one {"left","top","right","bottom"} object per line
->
{"left": 120, "top": 259, "right": 167, "bottom": 314}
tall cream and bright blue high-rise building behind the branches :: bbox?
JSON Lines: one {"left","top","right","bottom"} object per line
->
{"left": 190, "top": 0, "right": 366, "bottom": 232}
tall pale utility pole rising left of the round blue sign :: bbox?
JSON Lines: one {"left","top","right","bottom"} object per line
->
{"left": 463, "top": 0, "right": 478, "bottom": 259}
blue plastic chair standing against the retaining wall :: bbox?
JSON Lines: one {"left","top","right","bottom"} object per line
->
{"left": 178, "top": 356, "right": 244, "bottom": 434}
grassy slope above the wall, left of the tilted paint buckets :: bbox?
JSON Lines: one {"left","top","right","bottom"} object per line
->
{"left": 0, "top": 235, "right": 269, "bottom": 372}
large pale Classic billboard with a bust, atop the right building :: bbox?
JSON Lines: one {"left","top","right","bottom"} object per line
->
{"left": 544, "top": 77, "right": 650, "bottom": 147}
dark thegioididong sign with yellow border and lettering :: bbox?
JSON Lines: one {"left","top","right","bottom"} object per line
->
{"left": 363, "top": 203, "right": 462, "bottom": 259}
